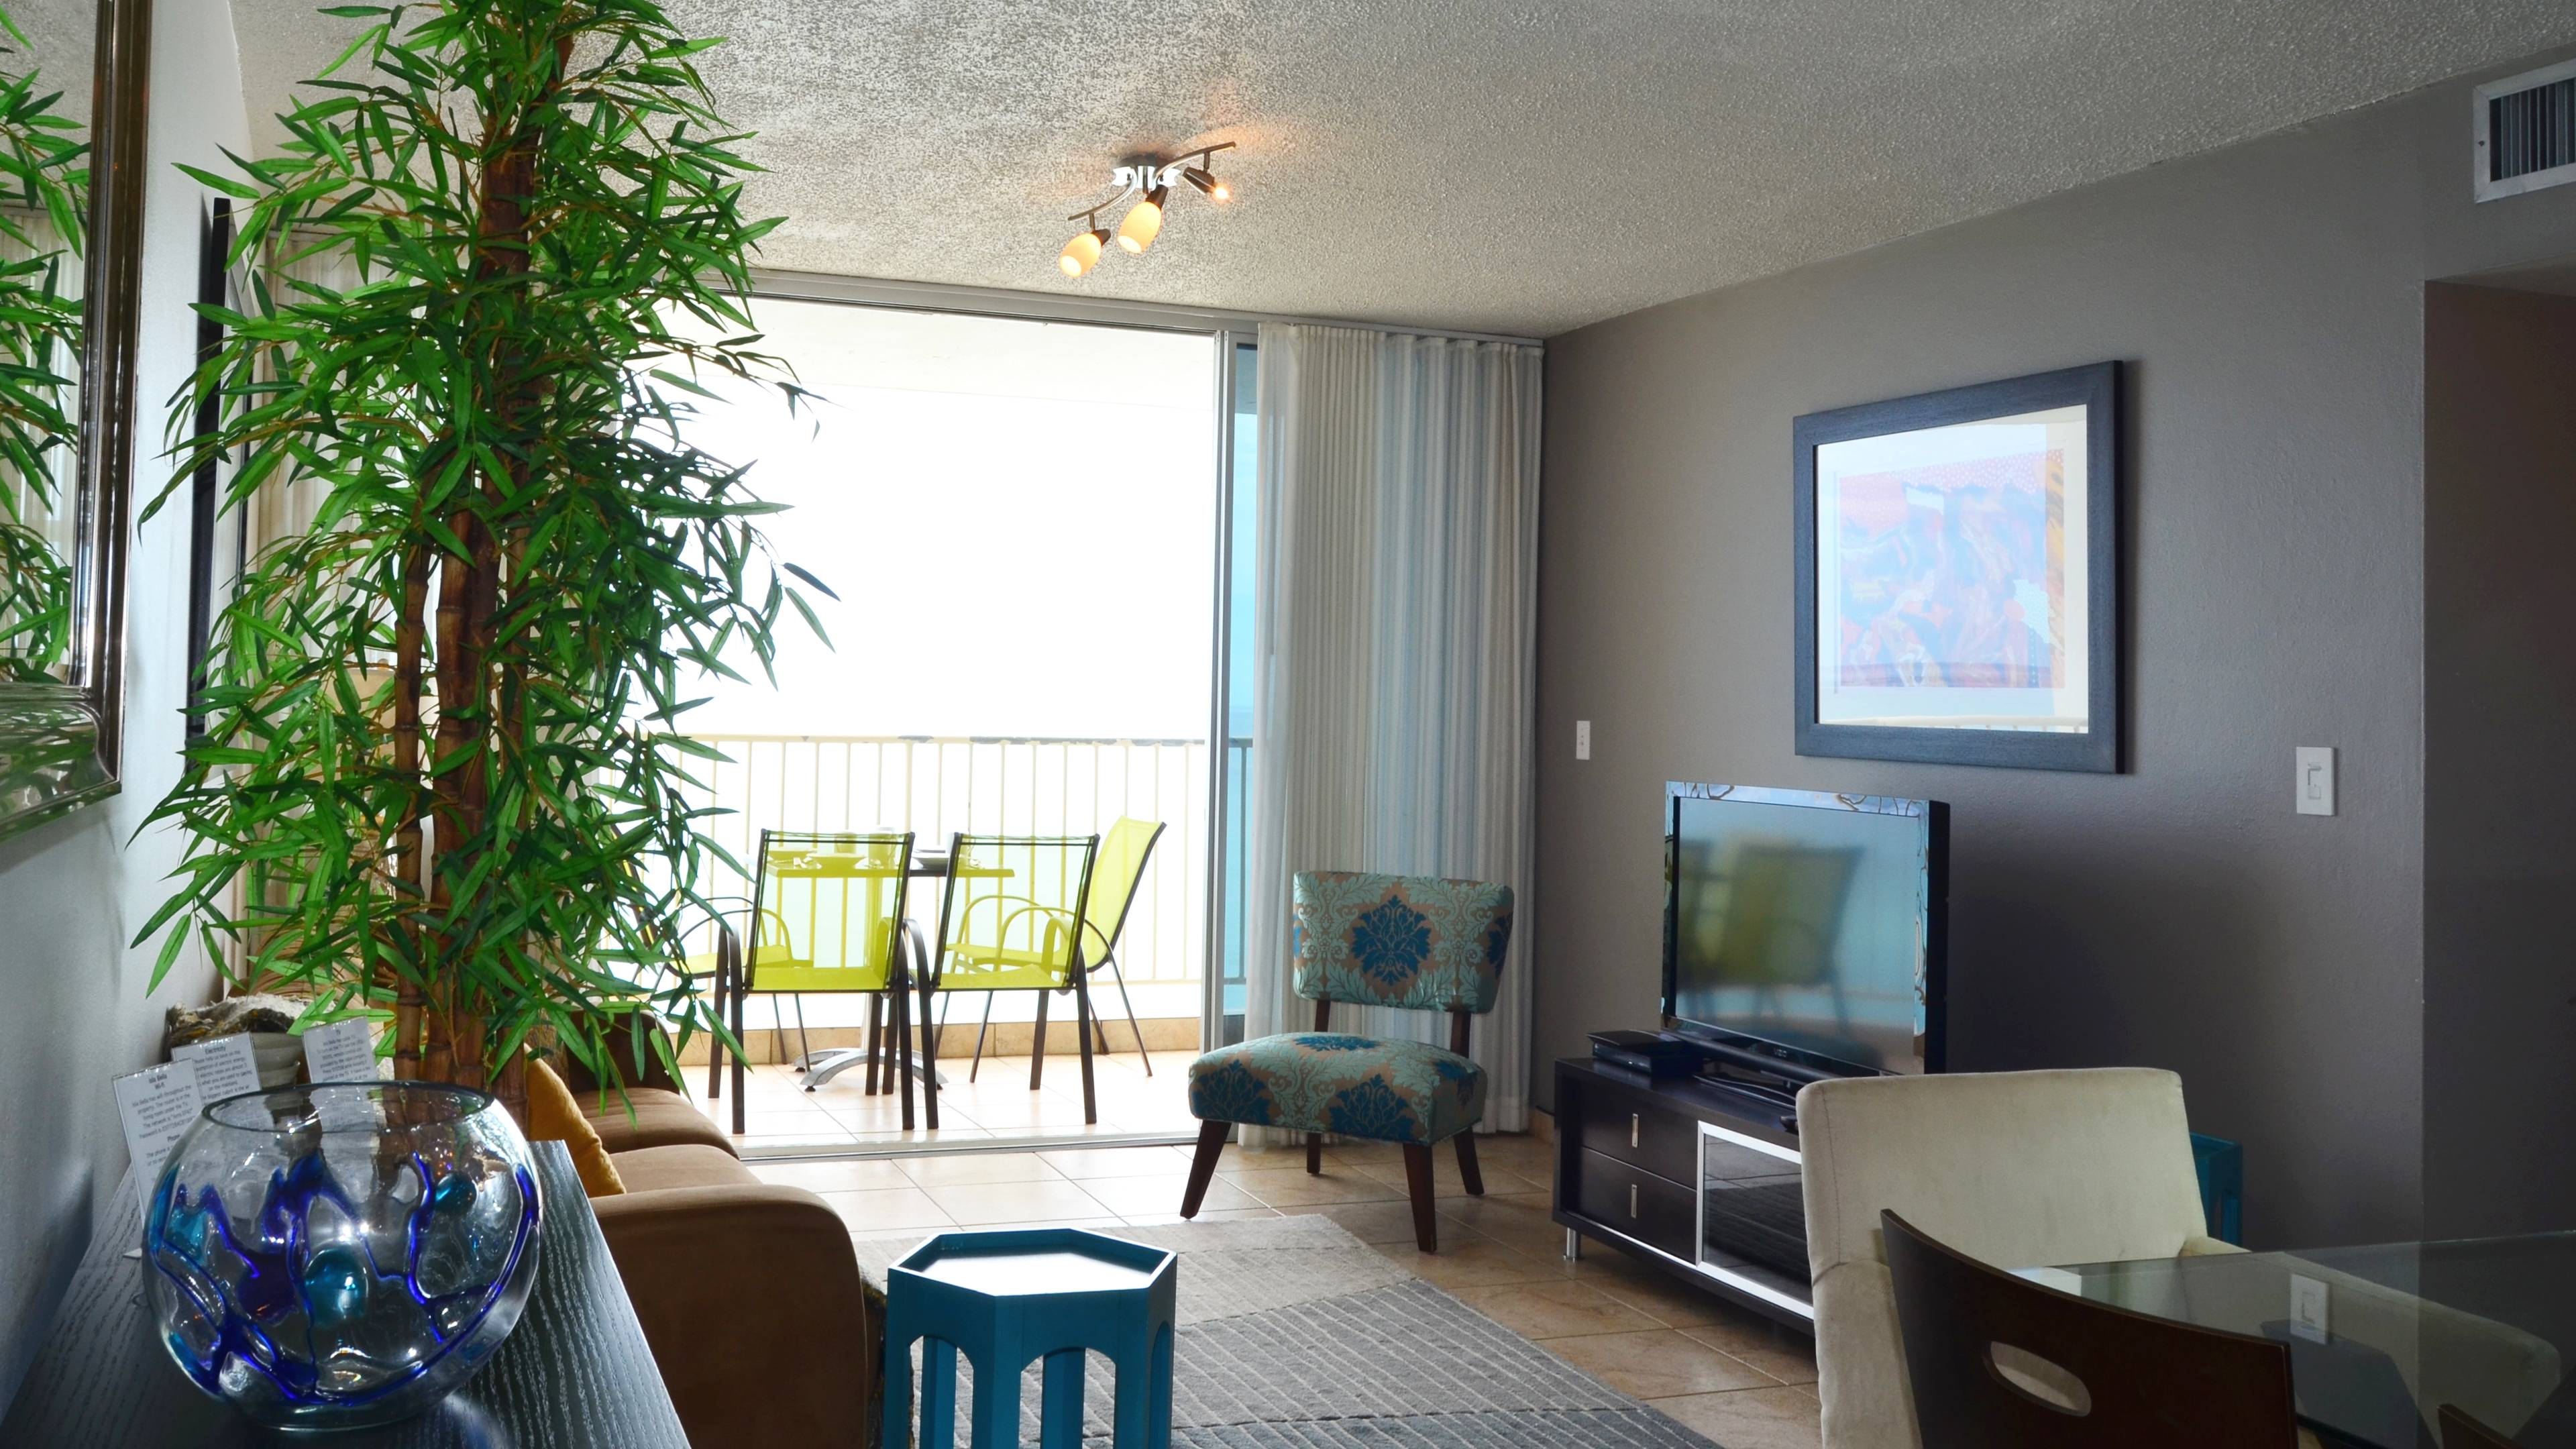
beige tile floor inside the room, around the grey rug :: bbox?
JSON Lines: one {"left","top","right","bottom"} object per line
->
{"left": 752, "top": 1129, "right": 1821, "bottom": 1449}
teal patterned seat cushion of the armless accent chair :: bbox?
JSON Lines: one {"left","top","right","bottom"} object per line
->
{"left": 1190, "top": 1031, "right": 1484, "bottom": 1142}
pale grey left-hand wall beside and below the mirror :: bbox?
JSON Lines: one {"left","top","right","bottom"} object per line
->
{"left": 0, "top": 0, "right": 250, "bottom": 1403}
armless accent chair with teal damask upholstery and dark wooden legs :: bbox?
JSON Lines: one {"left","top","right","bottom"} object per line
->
{"left": 1180, "top": 871, "right": 1512, "bottom": 1253}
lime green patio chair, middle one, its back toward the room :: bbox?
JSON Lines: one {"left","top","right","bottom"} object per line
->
{"left": 922, "top": 835, "right": 1100, "bottom": 1127}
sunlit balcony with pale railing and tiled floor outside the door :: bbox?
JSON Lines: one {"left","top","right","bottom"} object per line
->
{"left": 664, "top": 735, "right": 1242, "bottom": 1152}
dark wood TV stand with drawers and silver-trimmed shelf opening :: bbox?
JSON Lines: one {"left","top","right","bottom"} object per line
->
{"left": 1551, "top": 1041, "right": 1816, "bottom": 1333}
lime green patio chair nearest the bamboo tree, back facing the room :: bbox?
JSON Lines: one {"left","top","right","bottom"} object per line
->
{"left": 732, "top": 830, "right": 912, "bottom": 1129}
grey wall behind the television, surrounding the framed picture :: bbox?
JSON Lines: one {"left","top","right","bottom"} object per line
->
{"left": 1536, "top": 45, "right": 2576, "bottom": 1243}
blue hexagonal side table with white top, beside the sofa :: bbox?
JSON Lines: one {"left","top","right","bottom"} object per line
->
{"left": 883, "top": 1227, "right": 1180, "bottom": 1449}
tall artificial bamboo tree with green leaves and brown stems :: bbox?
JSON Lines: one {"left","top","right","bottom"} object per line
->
{"left": 144, "top": 0, "right": 814, "bottom": 1119}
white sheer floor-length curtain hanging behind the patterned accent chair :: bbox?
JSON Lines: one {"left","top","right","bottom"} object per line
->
{"left": 1244, "top": 325, "right": 1540, "bottom": 1137}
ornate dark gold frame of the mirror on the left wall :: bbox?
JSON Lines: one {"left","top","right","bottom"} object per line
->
{"left": 0, "top": 0, "right": 152, "bottom": 835}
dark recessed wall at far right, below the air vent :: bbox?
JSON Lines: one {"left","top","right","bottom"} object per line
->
{"left": 2424, "top": 284, "right": 2576, "bottom": 1238}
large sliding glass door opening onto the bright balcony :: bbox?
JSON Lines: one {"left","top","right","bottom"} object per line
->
{"left": 688, "top": 297, "right": 1257, "bottom": 1150}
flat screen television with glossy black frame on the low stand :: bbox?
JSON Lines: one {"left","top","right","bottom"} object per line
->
{"left": 1664, "top": 782, "right": 1950, "bottom": 1083}
